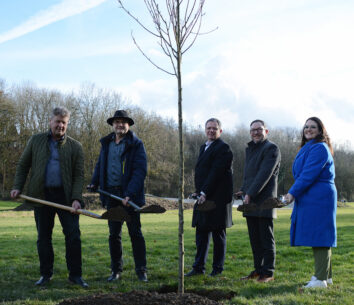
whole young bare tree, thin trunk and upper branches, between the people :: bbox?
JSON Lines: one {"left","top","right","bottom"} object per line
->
{"left": 117, "top": 0, "right": 209, "bottom": 294}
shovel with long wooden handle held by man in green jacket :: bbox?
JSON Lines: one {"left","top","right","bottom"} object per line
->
{"left": 19, "top": 195, "right": 130, "bottom": 222}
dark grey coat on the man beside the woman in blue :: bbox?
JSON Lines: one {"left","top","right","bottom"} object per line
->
{"left": 241, "top": 139, "right": 280, "bottom": 218}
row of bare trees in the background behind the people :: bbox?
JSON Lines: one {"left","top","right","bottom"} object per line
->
{"left": 0, "top": 80, "right": 354, "bottom": 201}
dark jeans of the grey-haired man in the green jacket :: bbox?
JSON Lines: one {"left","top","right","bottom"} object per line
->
{"left": 34, "top": 188, "right": 82, "bottom": 277}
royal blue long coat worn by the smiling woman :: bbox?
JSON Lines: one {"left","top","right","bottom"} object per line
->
{"left": 289, "top": 140, "right": 337, "bottom": 247}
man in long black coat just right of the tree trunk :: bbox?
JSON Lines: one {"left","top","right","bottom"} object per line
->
{"left": 186, "top": 118, "right": 233, "bottom": 276}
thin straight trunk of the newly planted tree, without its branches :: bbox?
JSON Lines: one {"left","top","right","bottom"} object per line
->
{"left": 176, "top": 1, "right": 184, "bottom": 294}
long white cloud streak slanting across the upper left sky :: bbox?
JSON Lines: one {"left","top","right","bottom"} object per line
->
{"left": 0, "top": 0, "right": 106, "bottom": 43}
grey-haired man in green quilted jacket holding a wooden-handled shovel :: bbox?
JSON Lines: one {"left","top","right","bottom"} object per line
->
{"left": 11, "top": 107, "right": 88, "bottom": 288}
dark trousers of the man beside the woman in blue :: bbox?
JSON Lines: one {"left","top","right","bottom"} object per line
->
{"left": 246, "top": 217, "right": 275, "bottom": 276}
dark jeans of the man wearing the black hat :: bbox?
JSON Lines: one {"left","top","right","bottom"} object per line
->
{"left": 107, "top": 188, "right": 146, "bottom": 272}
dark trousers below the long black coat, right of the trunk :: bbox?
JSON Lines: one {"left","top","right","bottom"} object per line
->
{"left": 193, "top": 227, "right": 226, "bottom": 272}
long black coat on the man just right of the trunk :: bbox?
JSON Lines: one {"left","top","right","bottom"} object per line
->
{"left": 192, "top": 138, "right": 233, "bottom": 231}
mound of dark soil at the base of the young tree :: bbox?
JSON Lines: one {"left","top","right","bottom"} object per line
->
{"left": 59, "top": 291, "right": 221, "bottom": 305}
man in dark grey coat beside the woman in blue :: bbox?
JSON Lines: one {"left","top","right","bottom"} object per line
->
{"left": 236, "top": 120, "right": 280, "bottom": 283}
